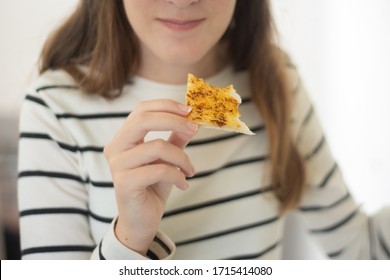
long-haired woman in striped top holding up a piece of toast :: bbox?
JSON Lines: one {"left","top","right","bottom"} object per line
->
{"left": 19, "top": 0, "right": 389, "bottom": 259}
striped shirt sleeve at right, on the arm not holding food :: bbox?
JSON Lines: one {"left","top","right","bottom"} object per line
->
{"left": 289, "top": 62, "right": 390, "bottom": 259}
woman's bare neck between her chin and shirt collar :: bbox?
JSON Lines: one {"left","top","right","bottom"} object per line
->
{"left": 138, "top": 41, "right": 228, "bottom": 84}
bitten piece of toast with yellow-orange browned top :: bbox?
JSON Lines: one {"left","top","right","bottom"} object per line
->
{"left": 186, "top": 74, "right": 254, "bottom": 135}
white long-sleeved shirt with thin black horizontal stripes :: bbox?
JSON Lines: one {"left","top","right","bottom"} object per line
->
{"left": 18, "top": 62, "right": 390, "bottom": 259}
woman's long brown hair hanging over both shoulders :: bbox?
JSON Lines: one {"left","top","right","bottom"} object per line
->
{"left": 40, "top": 0, "right": 305, "bottom": 212}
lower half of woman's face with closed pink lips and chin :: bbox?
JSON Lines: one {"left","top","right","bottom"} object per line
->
{"left": 124, "top": 0, "right": 236, "bottom": 80}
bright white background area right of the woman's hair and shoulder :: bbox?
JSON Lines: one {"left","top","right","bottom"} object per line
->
{"left": 273, "top": 0, "right": 390, "bottom": 212}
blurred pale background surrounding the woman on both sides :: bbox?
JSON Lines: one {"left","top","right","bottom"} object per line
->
{"left": 0, "top": 0, "right": 390, "bottom": 259}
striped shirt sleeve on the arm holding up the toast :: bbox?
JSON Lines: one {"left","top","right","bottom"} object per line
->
{"left": 18, "top": 79, "right": 175, "bottom": 260}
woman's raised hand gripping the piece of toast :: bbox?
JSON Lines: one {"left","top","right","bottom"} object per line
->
{"left": 104, "top": 100, "right": 198, "bottom": 255}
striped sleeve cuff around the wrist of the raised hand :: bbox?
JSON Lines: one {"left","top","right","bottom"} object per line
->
{"left": 91, "top": 218, "right": 176, "bottom": 260}
